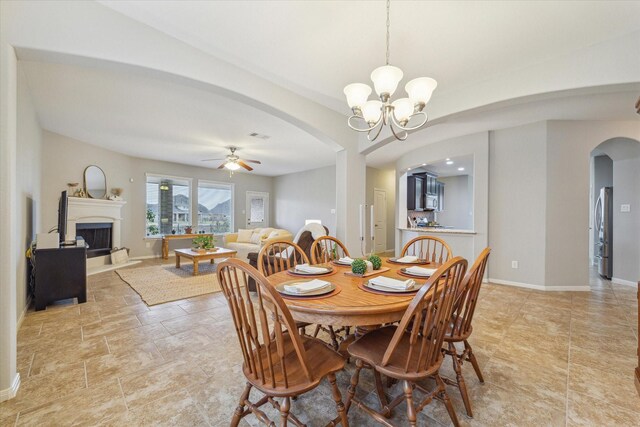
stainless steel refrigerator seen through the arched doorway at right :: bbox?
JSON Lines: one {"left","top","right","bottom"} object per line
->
{"left": 594, "top": 187, "right": 613, "bottom": 279}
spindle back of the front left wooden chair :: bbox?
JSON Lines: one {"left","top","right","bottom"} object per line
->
{"left": 218, "top": 259, "right": 313, "bottom": 389}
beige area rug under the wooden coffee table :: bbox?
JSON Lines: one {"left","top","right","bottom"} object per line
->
{"left": 116, "top": 262, "right": 222, "bottom": 305}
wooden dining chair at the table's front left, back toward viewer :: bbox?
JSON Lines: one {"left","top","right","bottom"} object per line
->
{"left": 218, "top": 259, "right": 349, "bottom": 427}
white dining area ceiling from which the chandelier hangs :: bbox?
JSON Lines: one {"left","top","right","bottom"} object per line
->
{"left": 100, "top": 0, "right": 640, "bottom": 113}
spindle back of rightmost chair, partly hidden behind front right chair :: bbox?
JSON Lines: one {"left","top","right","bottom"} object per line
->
{"left": 451, "top": 248, "right": 491, "bottom": 337}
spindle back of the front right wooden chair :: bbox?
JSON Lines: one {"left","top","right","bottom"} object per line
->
{"left": 382, "top": 257, "right": 467, "bottom": 374}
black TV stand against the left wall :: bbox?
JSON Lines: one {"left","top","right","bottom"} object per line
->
{"left": 31, "top": 245, "right": 87, "bottom": 311}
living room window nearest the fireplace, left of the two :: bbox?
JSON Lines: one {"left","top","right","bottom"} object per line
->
{"left": 146, "top": 175, "right": 192, "bottom": 237}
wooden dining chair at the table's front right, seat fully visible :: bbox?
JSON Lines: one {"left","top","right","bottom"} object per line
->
{"left": 346, "top": 257, "right": 467, "bottom": 426}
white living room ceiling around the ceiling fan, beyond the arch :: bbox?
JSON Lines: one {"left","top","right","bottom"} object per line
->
{"left": 20, "top": 61, "right": 335, "bottom": 176}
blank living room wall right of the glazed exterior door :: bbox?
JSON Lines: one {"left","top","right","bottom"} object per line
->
{"left": 273, "top": 166, "right": 336, "bottom": 236}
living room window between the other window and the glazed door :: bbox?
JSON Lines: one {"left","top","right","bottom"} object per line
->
{"left": 197, "top": 181, "right": 233, "bottom": 233}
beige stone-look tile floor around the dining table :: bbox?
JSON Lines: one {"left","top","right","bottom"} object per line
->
{"left": 0, "top": 260, "right": 640, "bottom": 426}
